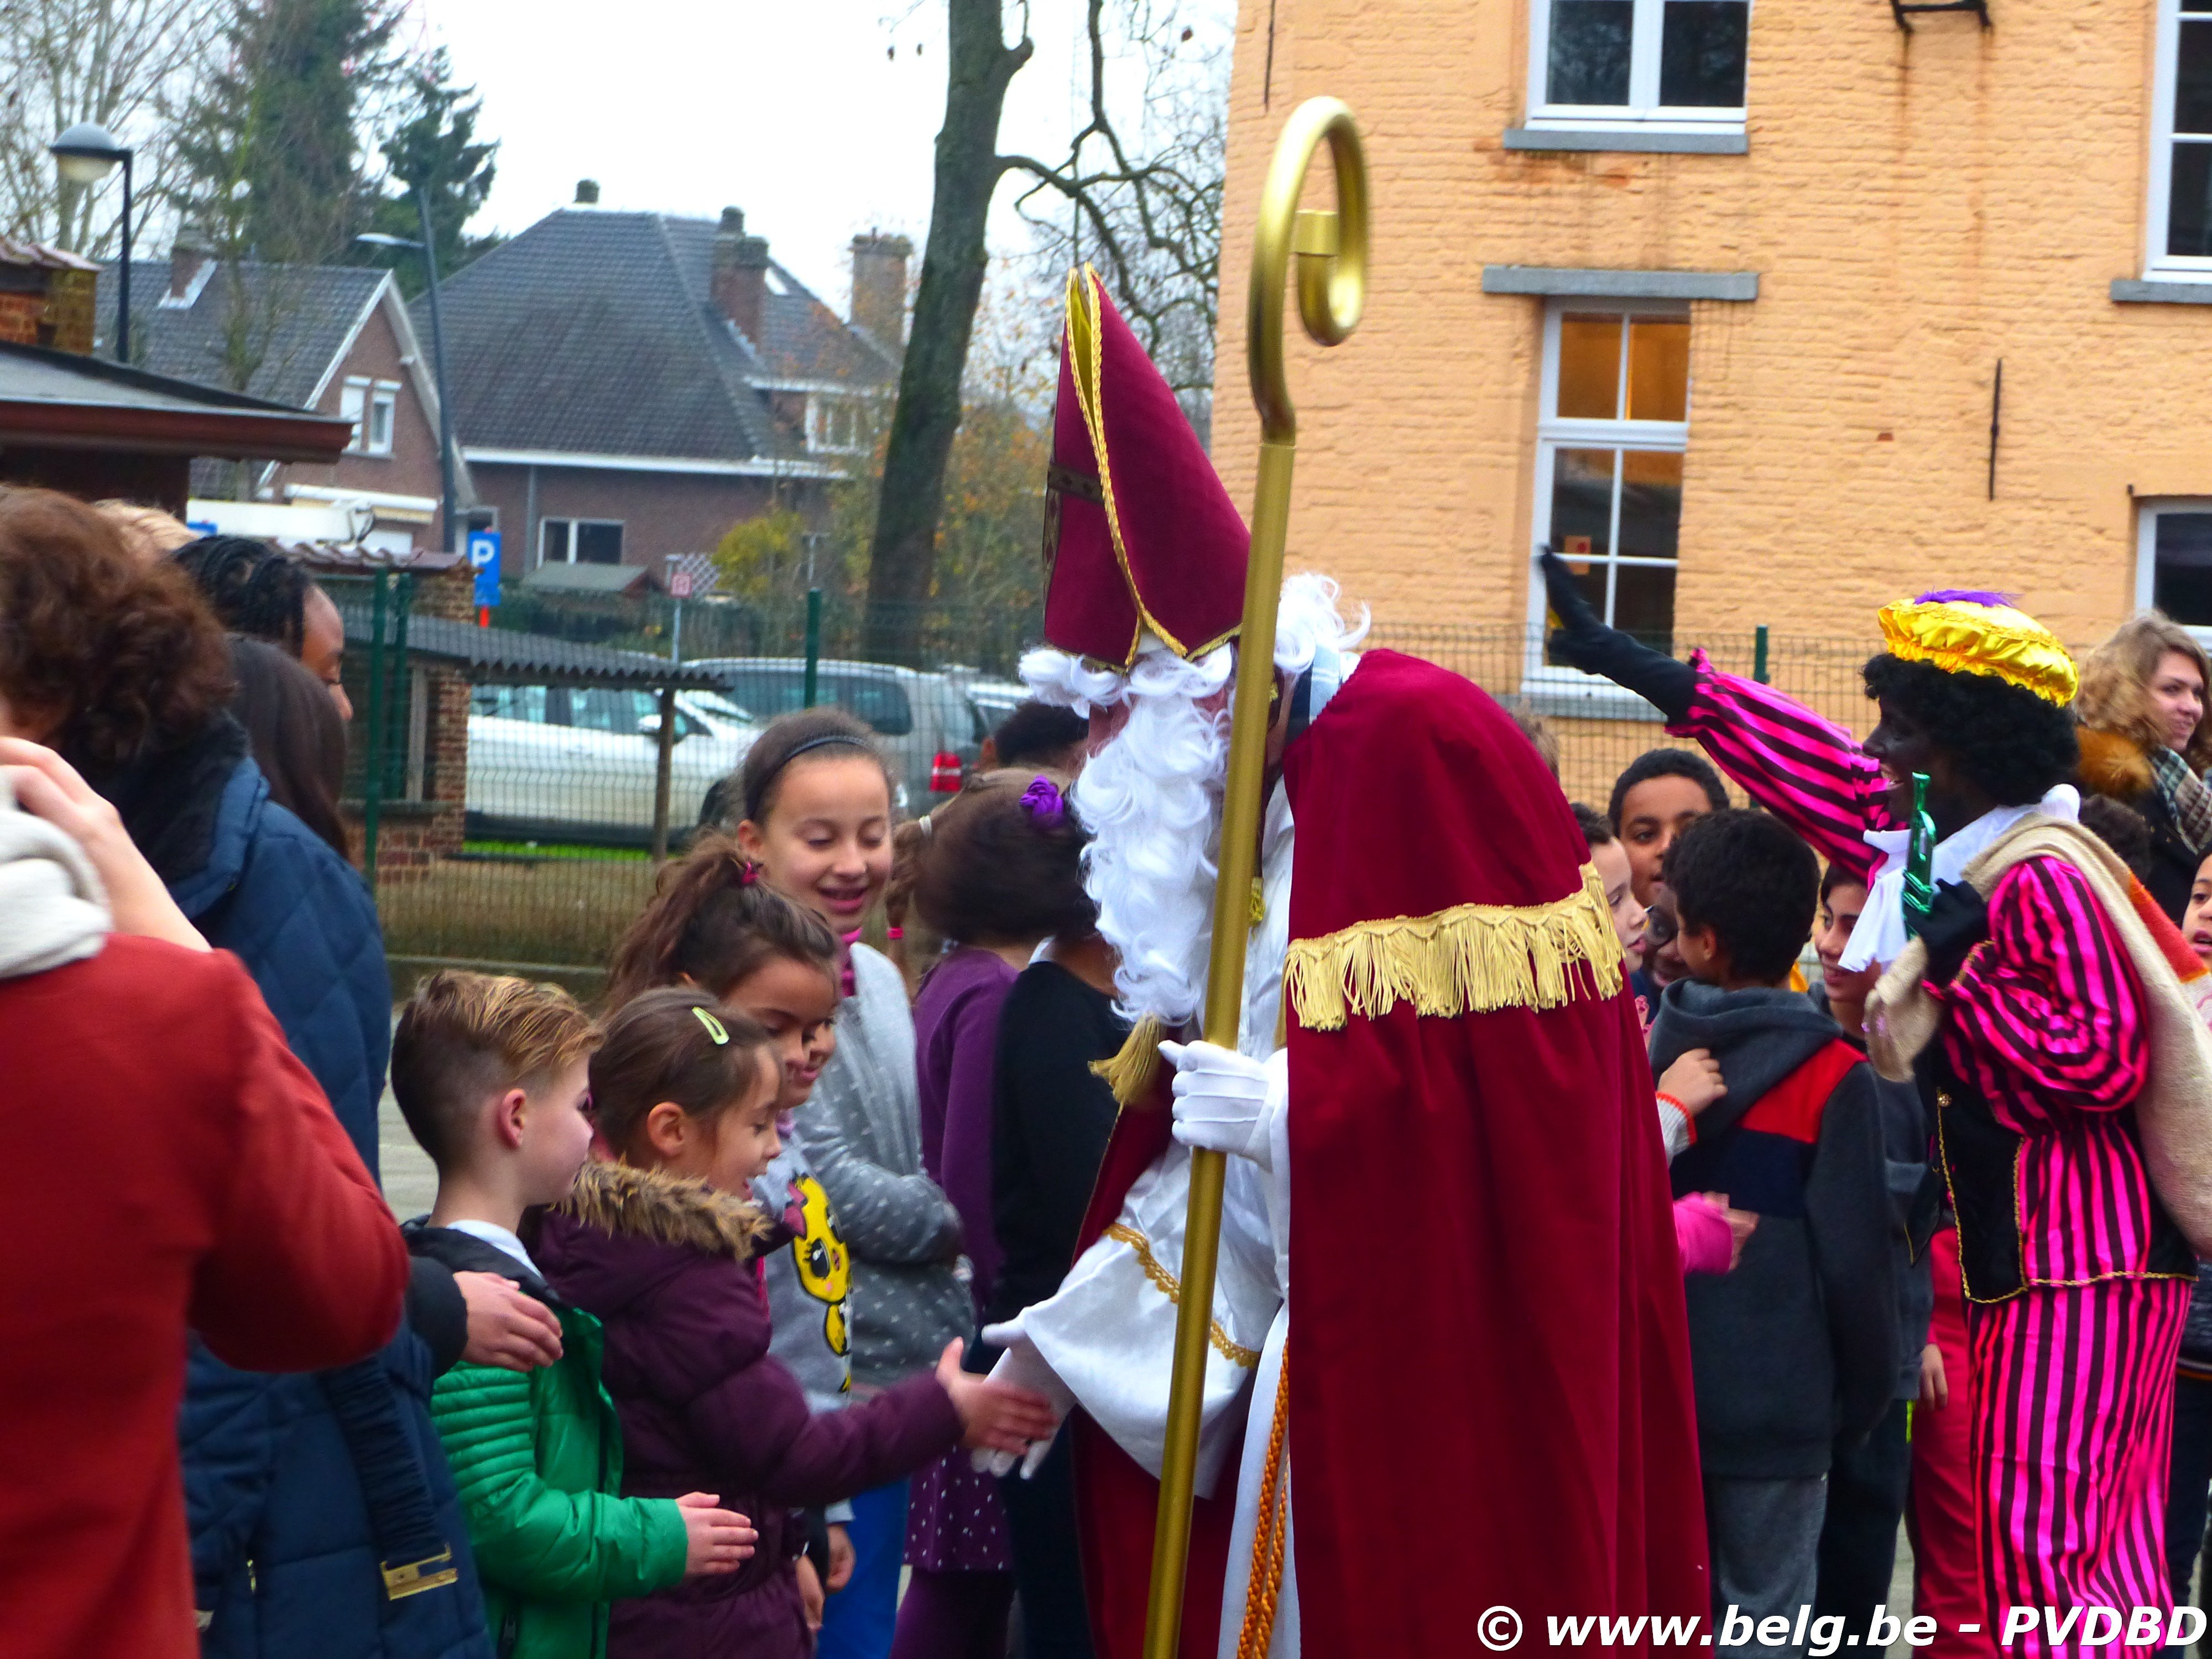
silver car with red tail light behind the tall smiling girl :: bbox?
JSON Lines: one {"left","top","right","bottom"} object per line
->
{"left": 684, "top": 657, "right": 991, "bottom": 812}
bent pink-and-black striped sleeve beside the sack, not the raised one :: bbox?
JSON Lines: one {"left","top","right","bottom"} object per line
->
{"left": 1929, "top": 858, "right": 2150, "bottom": 1130}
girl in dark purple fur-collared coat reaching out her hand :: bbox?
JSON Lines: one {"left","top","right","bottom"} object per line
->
{"left": 535, "top": 989, "right": 1053, "bottom": 1659}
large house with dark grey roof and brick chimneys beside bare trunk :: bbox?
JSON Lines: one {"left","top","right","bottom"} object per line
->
{"left": 445, "top": 181, "right": 911, "bottom": 580}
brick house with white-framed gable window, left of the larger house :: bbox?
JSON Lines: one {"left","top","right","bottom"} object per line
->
{"left": 95, "top": 249, "right": 469, "bottom": 553}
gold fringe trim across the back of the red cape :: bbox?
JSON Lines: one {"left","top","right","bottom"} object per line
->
{"left": 1283, "top": 865, "right": 1621, "bottom": 1031}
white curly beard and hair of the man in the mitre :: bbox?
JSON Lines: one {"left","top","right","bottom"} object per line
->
{"left": 1022, "top": 575, "right": 1367, "bottom": 1029}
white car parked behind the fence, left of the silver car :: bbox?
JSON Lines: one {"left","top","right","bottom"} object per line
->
{"left": 469, "top": 686, "right": 761, "bottom": 845}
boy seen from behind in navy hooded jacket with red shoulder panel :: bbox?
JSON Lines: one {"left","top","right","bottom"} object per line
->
{"left": 1652, "top": 812, "right": 1898, "bottom": 1655}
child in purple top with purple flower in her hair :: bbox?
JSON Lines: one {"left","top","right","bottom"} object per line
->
{"left": 891, "top": 772, "right": 1097, "bottom": 1659}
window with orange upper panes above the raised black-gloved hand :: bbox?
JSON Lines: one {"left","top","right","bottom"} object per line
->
{"left": 1526, "top": 299, "right": 1690, "bottom": 686}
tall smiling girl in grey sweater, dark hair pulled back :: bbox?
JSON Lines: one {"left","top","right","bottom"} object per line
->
{"left": 737, "top": 708, "right": 975, "bottom": 1659}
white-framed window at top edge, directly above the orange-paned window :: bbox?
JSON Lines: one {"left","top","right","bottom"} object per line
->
{"left": 1528, "top": 0, "right": 1752, "bottom": 133}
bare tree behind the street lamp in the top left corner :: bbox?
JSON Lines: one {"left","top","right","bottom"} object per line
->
{"left": 0, "top": 0, "right": 217, "bottom": 259}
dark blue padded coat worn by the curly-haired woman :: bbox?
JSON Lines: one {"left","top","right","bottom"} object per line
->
{"left": 100, "top": 719, "right": 491, "bottom": 1659}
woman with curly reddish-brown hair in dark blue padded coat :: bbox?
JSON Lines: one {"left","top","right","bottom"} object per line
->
{"left": 0, "top": 489, "right": 518, "bottom": 1659}
